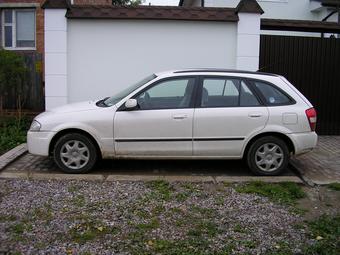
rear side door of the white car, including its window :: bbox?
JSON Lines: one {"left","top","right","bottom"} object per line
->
{"left": 193, "top": 76, "right": 268, "bottom": 158}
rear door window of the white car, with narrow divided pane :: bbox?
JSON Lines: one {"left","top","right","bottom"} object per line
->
{"left": 201, "top": 78, "right": 260, "bottom": 107}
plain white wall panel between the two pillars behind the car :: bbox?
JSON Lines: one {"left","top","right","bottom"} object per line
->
{"left": 67, "top": 19, "right": 237, "bottom": 103}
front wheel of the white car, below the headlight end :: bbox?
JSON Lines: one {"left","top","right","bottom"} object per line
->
{"left": 53, "top": 133, "right": 98, "bottom": 174}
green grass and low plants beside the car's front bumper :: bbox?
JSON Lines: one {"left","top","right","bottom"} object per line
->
{"left": 0, "top": 117, "right": 31, "bottom": 155}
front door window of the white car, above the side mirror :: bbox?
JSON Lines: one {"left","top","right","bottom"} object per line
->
{"left": 136, "top": 78, "right": 195, "bottom": 110}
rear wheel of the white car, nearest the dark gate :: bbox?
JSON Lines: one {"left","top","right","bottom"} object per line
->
{"left": 247, "top": 136, "right": 290, "bottom": 176}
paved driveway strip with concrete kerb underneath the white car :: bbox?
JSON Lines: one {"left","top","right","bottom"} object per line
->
{"left": 0, "top": 153, "right": 301, "bottom": 182}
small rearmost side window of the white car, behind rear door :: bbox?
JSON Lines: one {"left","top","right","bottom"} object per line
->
{"left": 254, "top": 81, "right": 292, "bottom": 105}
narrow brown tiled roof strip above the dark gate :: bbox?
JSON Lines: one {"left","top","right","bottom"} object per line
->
{"left": 261, "top": 19, "right": 340, "bottom": 33}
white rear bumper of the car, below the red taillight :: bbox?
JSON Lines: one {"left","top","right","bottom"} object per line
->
{"left": 288, "top": 132, "right": 318, "bottom": 155}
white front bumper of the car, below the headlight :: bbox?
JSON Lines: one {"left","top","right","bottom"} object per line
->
{"left": 27, "top": 131, "right": 55, "bottom": 156}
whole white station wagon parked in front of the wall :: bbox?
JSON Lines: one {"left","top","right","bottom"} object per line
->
{"left": 27, "top": 69, "right": 317, "bottom": 175}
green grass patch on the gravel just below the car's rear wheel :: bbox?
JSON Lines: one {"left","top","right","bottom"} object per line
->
{"left": 235, "top": 181, "right": 306, "bottom": 205}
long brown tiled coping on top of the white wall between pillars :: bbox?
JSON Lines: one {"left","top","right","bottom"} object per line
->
{"left": 66, "top": 5, "right": 238, "bottom": 22}
